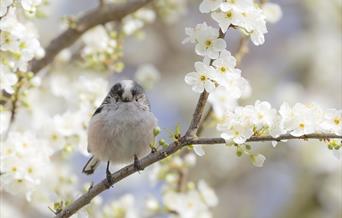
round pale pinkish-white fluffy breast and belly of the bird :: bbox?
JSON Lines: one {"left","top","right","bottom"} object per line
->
{"left": 88, "top": 102, "right": 156, "bottom": 163}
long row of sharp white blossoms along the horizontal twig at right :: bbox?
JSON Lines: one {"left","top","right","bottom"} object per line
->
{"left": 217, "top": 101, "right": 342, "bottom": 144}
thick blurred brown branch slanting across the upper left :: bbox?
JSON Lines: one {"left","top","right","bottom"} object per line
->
{"left": 31, "top": 0, "right": 152, "bottom": 74}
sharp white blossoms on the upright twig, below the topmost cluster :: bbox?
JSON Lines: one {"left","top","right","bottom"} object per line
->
{"left": 184, "top": 23, "right": 249, "bottom": 96}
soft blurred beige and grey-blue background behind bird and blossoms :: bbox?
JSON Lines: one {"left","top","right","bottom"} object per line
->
{"left": 1, "top": 0, "right": 342, "bottom": 218}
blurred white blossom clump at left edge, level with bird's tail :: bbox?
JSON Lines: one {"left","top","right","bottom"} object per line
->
{"left": 0, "top": 131, "right": 52, "bottom": 200}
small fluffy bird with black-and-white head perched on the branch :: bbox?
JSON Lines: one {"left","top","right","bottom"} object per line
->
{"left": 82, "top": 80, "right": 157, "bottom": 184}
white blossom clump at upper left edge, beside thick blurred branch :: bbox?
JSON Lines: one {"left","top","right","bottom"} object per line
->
{"left": 0, "top": 4, "right": 44, "bottom": 94}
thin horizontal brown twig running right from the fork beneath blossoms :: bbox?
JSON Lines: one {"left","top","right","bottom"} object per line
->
{"left": 187, "top": 133, "right": 342, "bottom": 145}
